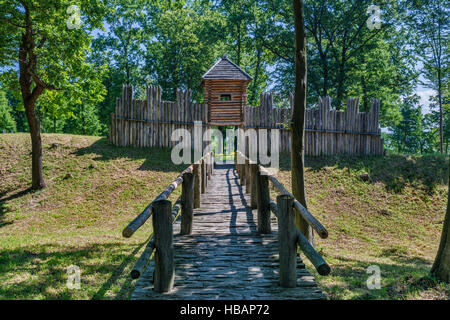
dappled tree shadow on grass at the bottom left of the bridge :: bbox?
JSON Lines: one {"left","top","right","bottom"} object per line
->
{"left": 0, "top": 242, "right": 151, "bottom": 300}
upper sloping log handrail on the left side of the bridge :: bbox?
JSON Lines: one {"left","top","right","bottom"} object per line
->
{"left": 122, "top": 153, "right": 210, "bottom": 238}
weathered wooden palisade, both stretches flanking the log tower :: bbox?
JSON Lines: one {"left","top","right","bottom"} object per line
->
{"left": 109, "top": 85, "right": 384, "bottom": 156}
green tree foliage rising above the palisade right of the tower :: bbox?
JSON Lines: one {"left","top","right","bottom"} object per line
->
{"left": 255, "top": 0, "right": 416, "bottom": 125}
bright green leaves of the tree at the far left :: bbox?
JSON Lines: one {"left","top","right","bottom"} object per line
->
{"left": 0, "top": 0, "right": 106, "bottom": 131}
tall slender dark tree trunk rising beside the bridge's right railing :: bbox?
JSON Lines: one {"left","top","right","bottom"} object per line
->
{"left": 291, "top": 0, "right": 314, "bottom": 244}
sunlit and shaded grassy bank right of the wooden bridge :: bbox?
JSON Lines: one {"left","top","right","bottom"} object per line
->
{"left": 272, "top": 155, "right": 450, "bottom": 299}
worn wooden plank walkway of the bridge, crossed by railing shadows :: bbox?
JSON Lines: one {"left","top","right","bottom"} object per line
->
{"left": 131, "top": 165, "right": 325, "bottom": 300}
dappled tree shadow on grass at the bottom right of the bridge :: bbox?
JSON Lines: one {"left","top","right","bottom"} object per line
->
{"left": 317, "top": 254, "right": 450, "bottom": 300}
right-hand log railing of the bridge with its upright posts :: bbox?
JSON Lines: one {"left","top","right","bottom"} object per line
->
{"left": 235, "top": 152, "right": 331, "bottom": 287}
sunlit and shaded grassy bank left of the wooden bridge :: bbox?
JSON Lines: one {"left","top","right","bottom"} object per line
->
{"left": 0, "top": 134, "right": 185, "bottom": 299}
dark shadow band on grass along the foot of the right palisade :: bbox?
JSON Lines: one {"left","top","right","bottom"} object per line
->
{"left": 280, "top": 153, "right": 448, "bottom": 195}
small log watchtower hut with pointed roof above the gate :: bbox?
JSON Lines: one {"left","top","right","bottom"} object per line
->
{"left": 202, "top": 55, "right": 253, "bottom": 126}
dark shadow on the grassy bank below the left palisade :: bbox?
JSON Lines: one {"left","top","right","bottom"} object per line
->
{"left": 74, "top": 138, "right": 188, "bottom": 172}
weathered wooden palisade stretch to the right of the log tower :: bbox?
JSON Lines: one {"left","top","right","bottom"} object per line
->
{"left": 242, "top": 93, "right": 384, "bottom": 156}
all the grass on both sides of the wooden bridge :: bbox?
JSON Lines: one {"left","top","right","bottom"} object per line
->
{"left": 0, "top": 134, "right": 449, "bottom": 299}
